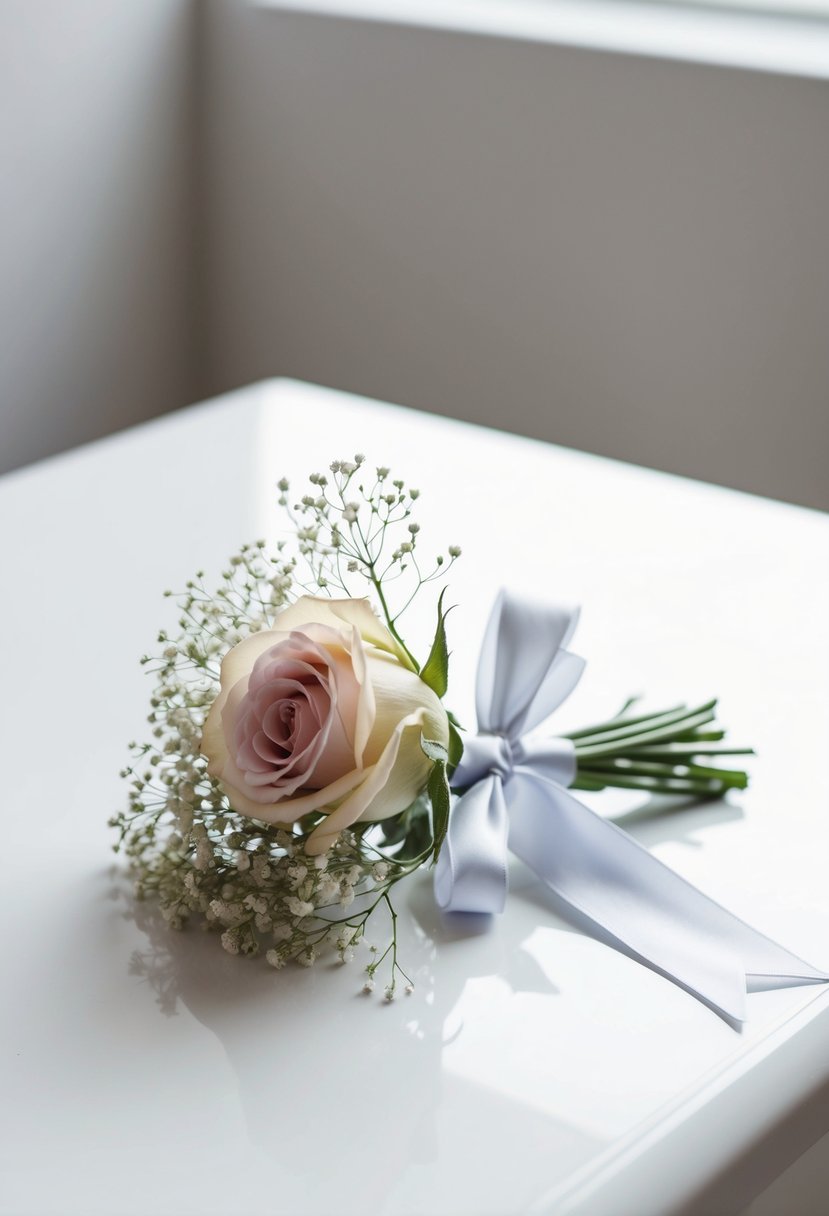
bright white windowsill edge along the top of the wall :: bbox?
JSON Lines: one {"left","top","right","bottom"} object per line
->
{"left": 255, "top": 0, "right": 829, "bottom": 79}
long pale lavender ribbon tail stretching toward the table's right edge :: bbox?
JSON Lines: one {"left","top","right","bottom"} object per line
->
{"left": 507, "top": 767, "right": 829, "bottom": 1023}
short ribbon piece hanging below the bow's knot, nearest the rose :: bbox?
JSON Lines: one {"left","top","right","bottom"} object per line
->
{"left": 435, "top": 772, "right": 508, "bottom": 912}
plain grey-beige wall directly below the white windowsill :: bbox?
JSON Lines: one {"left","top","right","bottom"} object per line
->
{"left": 200, "top": 0, "right": 829, "bottom": 507}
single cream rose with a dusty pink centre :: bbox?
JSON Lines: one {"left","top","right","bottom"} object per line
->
{"left": 202, "top": 596, "right": 449, "bottom": 854}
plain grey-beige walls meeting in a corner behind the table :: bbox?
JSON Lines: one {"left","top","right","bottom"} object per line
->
{"left": 0, "top": 0, "right": 829, "bottom": 508}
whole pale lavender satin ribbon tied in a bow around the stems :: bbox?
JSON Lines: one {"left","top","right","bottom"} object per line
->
{"left": 435, "top": 591, "right": 829, "bottom": 1023}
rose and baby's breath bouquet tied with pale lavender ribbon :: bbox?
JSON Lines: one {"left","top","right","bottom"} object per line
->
{"left": 111, "top": 455, "right": 821, "bottom": 1017}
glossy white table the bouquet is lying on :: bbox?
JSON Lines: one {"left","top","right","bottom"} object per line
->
{"left": 0, "top": 381, "right": 829, "bottom": 1216}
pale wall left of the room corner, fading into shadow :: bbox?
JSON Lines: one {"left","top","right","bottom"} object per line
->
{"left": 0, "top": 0, "right": 199, "bottom": 471}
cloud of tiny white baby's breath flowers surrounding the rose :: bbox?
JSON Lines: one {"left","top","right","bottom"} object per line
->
{"left": 109, "top": 455, "right": 461, "bottom": 1000}
